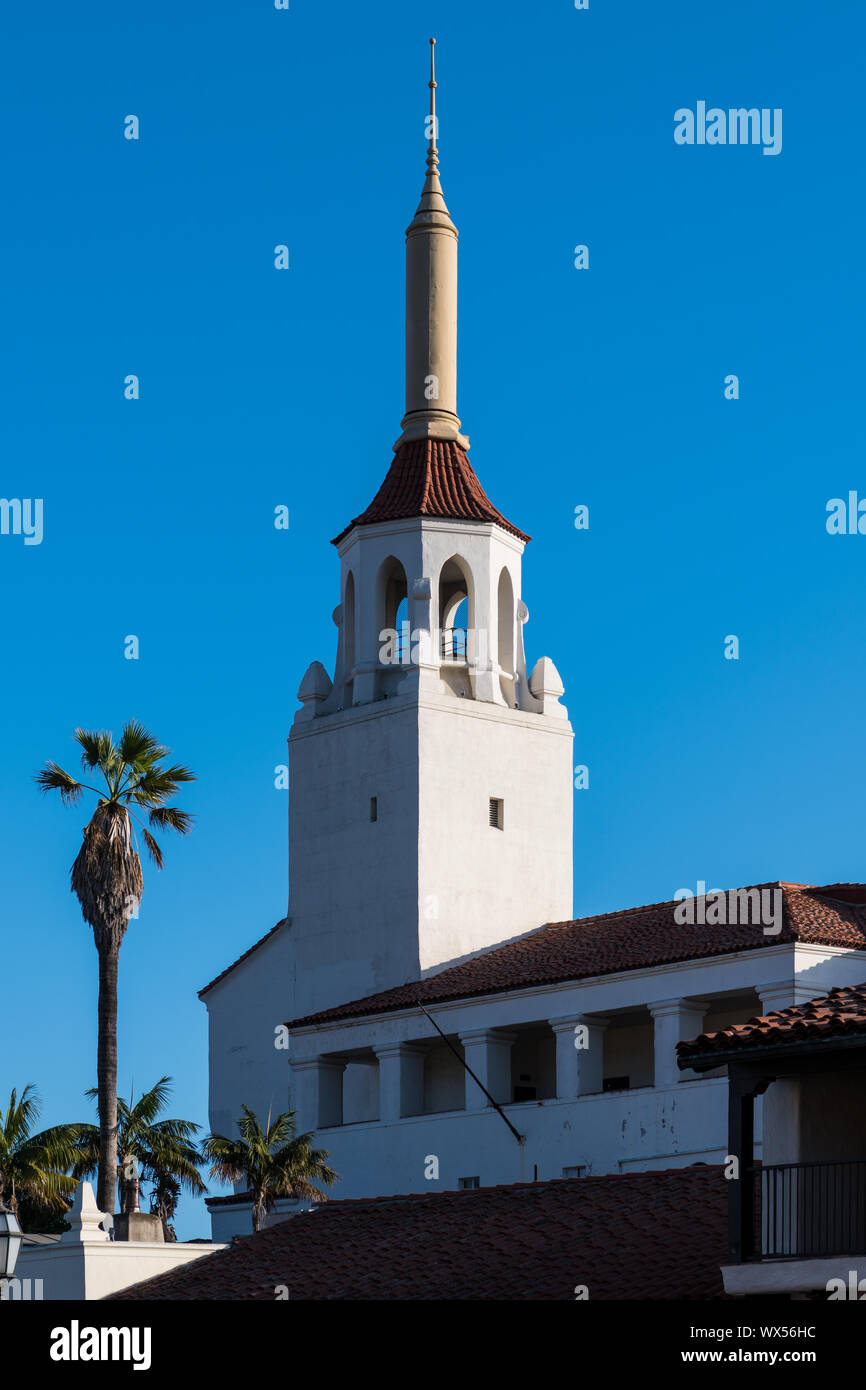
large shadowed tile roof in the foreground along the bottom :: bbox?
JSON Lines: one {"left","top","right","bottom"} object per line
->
{"left": 111, "top": 1166, "right": 728, "bottom": 1302}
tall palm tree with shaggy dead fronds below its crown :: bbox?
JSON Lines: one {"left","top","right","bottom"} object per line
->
{"left": 36, "top": 720, "right": 195, "bottom": 1212}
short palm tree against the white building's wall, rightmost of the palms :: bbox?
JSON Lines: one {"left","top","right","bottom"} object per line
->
{"left": 202, "top": 1105, "right": 339, "bottom": 1230}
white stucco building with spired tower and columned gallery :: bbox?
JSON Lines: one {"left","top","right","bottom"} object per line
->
{"left": 202, "top": 43, "right": 866, "bottom": 1240}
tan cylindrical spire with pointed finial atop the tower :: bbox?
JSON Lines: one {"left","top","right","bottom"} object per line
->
{"left": 395, "top": 39, "right": 468, "bottom": 449}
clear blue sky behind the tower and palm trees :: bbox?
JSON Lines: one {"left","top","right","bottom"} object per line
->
{"left": 0, "top": 0, "right": 866, "bottom": 1237}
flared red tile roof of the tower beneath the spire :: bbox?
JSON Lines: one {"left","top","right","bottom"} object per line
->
{"left": 331, "top": 439, "right": 530, "bottom": 545}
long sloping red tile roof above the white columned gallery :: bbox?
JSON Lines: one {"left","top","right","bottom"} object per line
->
{"left": 289, "top": 883, "right": 866, "bottom": 1027}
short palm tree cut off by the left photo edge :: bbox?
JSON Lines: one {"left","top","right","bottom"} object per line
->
{"left": 0, "top": 1086, "right": 85, "bottom": 1213}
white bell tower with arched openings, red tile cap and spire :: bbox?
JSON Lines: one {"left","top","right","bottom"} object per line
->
{"left": 289, "top": 39, "right": 573, "bottom": 1017}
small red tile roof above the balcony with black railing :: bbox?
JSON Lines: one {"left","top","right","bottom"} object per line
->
{"left": 677, "top": 984, "right": 866, "bottom": 1068}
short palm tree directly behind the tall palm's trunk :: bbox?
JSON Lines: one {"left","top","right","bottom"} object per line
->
{"left": 72, "top": 1076, "right": 207, "bottom": 1234}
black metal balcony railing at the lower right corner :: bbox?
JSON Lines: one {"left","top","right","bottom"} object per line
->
{"left": 746, "top": 1159, "right": 866, "bottom": 1259}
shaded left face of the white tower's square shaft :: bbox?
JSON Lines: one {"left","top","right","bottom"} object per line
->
{"left": 285, "top": 699, "right": 418, "bottom": 1019}
